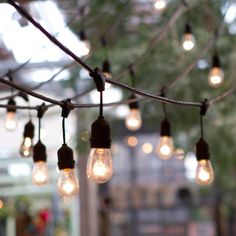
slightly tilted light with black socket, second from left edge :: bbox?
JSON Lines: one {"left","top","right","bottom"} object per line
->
{"left": 20, "top": 120, "right": 34, "bottom": 158}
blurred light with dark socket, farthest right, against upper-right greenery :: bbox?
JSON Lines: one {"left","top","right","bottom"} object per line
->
{"left": 208, "top": 54, "right": 224, "bottom": 88}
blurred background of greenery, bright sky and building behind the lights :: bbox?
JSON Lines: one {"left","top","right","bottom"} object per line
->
{"left": 0, "top": 0, "right": 236, "bottom": 236}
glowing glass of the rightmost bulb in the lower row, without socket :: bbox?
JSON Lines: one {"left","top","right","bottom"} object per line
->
{"left": 195, "top": 160, "right": 214, "bottom": 185}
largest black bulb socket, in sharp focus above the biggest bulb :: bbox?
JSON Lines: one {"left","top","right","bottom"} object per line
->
{"left": 90, "top": 116, "right": 111, "bottom": 148}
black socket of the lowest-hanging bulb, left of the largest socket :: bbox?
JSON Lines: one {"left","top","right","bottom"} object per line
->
{"left": 57, "top": 144, "right": 75, "bottom": 170}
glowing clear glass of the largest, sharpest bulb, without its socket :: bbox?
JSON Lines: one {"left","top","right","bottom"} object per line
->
{"left": 87, "top": 148, "right": 113, "bottom": 184}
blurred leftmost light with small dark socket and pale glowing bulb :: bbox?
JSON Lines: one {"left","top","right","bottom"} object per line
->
{"left": 4, "top": 99, "right": 18, "bottom": 131}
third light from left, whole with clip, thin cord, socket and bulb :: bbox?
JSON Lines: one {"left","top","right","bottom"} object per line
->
{"left": 32, "top": 104, "right": 49, "bottom": 185}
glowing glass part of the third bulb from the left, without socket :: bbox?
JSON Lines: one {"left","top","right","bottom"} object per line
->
{"left": 32, "top": 161, "right": 49, "bottom": 185}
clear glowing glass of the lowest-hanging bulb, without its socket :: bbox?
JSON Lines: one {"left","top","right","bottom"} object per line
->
{"left": 57, "top": 168, "right": 79, "bottom": 198}
